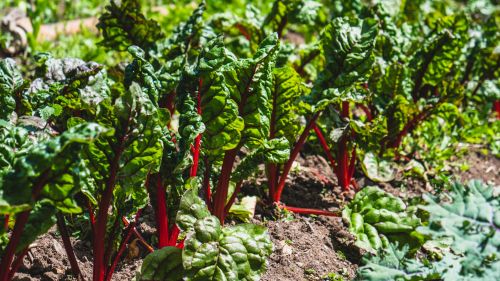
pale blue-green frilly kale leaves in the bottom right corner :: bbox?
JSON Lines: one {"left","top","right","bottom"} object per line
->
{"left": 358, "top": 181, "right": 500, "bottom": 281}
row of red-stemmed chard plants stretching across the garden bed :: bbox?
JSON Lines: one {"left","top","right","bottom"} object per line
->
{"left": 0, "top": 0, "right": 500, "bottom": 281}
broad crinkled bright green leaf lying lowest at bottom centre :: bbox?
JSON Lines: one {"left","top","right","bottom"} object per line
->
{"left": 179, "top": 186, "right": 272, "bottom": 280}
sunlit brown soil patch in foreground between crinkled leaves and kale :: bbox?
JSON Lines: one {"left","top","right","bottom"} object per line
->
{"left": 262, "top": 217, "right": 357, "bottom": 281}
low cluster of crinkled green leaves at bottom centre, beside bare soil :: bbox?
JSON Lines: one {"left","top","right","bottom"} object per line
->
{"left": 139, "top": 187, "right": 272, "bottom": 280}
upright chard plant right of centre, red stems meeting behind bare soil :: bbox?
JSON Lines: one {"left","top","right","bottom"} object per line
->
{"left": 286, "top": 15, "right": 378, "bottom": 190}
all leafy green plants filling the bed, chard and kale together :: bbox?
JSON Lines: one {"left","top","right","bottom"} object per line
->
{"left": 0, "top": 0, "right": 500, "bottom": 280}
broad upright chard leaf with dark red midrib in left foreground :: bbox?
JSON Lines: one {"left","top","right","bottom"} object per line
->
{"left": 86, "top": 83, "right": 164, "bottom": 212}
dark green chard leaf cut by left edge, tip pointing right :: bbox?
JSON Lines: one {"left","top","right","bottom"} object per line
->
{"left": 0, "top": 123, "right": 108, "bottom": 214}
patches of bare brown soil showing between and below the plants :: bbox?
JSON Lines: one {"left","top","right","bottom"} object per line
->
{"left": 9, "top": 152, "right": 500, "bottom": 281}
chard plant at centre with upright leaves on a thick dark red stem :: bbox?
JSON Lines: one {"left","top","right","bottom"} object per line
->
{"left": 191, "top": 35, "right": 288, "bottom": 222}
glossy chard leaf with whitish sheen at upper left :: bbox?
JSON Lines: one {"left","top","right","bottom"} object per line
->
{"left": 23, "top": 53, "right": 111, "bottom": 123}
